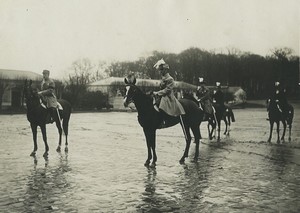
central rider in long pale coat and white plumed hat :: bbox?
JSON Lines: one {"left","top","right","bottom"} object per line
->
{"left": 153, "top": 59, "right": 185, "bottom": 128}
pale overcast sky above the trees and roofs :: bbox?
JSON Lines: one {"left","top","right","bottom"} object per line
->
{"left": 0, "top": 0, "right": 300, "bottom": 78}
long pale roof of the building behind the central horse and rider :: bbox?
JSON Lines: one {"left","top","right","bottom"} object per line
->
{"left": 89, "top": 77, "right": 197, "bottom": 89}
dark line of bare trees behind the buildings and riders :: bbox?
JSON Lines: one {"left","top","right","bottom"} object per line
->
{"left": 62, "top": 48, "right": 299, "bottom": 106}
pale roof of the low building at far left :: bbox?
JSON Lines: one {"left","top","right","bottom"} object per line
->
{"left": 0, "top": 69, "right": 43, "bottom": 80}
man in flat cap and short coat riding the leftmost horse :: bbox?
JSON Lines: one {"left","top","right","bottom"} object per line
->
{"left": 38, "top": 70, "right": 58, "bottom": 123}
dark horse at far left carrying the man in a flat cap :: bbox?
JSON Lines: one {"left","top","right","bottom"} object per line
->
{"left": 23, "top": 80, "right": 72, "bottom": 157}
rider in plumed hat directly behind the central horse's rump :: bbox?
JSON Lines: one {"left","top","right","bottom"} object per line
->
{"left": 196, "top": 78, "right": 214, "bottom": 120}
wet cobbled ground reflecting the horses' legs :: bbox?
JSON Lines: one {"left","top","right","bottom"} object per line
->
{"left": 0, "top": 105, "right": 300, "bottom": 212}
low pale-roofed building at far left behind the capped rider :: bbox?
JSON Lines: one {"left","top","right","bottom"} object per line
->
{"left": 0, "top": 69, "right": 43, "bottom": 109}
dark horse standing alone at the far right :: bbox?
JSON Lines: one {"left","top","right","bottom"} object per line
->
{"left": 268, "top": 99, "right": 294, "bottom": 143}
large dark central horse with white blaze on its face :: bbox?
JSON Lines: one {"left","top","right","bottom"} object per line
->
{"left": 124, "top": 78, "right": 203, "bottom": 166}
